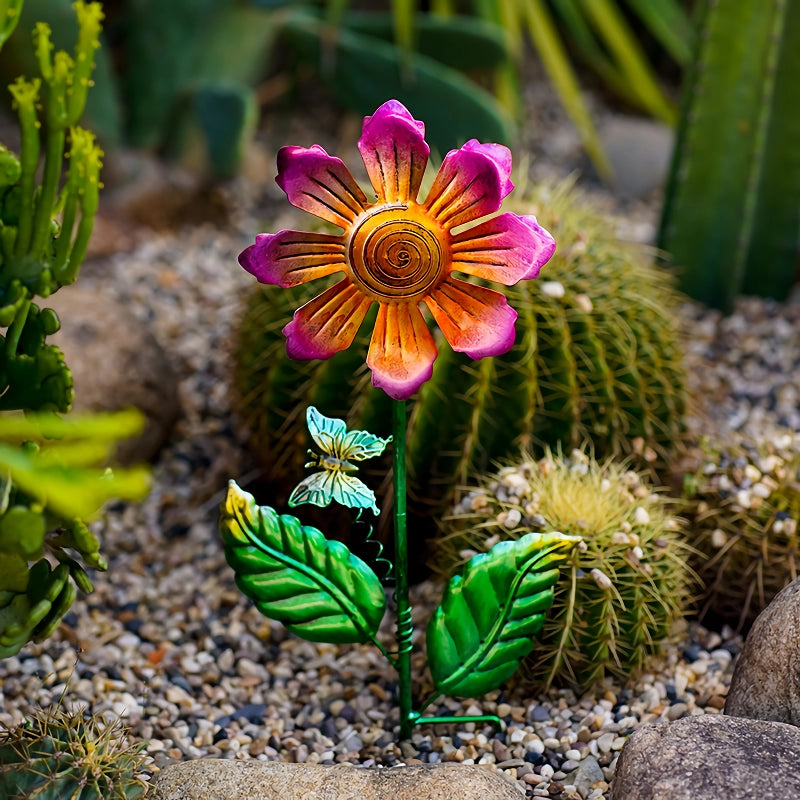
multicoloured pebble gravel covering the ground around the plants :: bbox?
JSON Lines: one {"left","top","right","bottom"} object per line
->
{"left": 0, "top": 194, "right": 800, "bottom": 798}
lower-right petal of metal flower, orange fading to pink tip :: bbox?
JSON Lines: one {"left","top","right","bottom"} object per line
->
{"left": 424, "top": 277, "right": 517, "bottom": 359}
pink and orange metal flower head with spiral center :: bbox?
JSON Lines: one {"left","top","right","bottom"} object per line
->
{"left": 239, "top": 100, "right": 555, "bottom": 400}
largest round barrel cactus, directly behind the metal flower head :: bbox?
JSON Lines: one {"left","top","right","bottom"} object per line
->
{"left": 234, "top": 180, "right": 685, "bottom": 516}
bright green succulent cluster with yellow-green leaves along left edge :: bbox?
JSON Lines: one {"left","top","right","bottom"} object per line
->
{"left": 0, "top": 0, "right": 147, "bottom": 657}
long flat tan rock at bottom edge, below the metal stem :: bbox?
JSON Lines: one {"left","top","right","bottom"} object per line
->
{"left": 148, "top": 758, "right": 522, "bottom": 800}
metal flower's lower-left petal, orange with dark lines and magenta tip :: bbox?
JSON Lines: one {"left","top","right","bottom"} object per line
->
{"left": 283, "top": 278, "right": 372, "bottom": 360}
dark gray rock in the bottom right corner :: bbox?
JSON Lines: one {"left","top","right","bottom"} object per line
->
{"left": 611, "top": 714, "right": 800, "bottom": 800}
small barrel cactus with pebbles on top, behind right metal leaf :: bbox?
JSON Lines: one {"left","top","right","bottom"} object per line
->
{"left": 434, "top": 451, "right": 691, "bottom": 690}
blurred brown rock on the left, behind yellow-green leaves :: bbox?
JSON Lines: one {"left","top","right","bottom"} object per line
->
{"left": 43, "top": 285, "right": 180, "bottom": 464}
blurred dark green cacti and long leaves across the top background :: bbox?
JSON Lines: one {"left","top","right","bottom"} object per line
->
{"left": 0, "top": 0, "right": 800, "bottom": 309}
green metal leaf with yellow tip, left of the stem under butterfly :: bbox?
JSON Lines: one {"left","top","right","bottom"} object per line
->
{"left": 220, "top": 481, "right": 386, "bottom": 643}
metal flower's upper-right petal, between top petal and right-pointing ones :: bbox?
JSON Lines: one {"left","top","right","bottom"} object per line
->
{"left": 425, "top": 139, "right": 514, "bottom": 228}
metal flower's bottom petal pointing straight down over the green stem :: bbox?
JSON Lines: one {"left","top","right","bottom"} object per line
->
{"left": 367, "top": 303, "right": 437, "bottom": 400}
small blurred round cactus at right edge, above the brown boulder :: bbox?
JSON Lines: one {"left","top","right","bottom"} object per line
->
{"left": 682, "top": 431, "right": 800, "bottom": 629}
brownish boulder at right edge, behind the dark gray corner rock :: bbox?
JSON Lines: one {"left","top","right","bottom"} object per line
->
{"left": 725, "top": 578, "right": 800, "bottom": 726}
